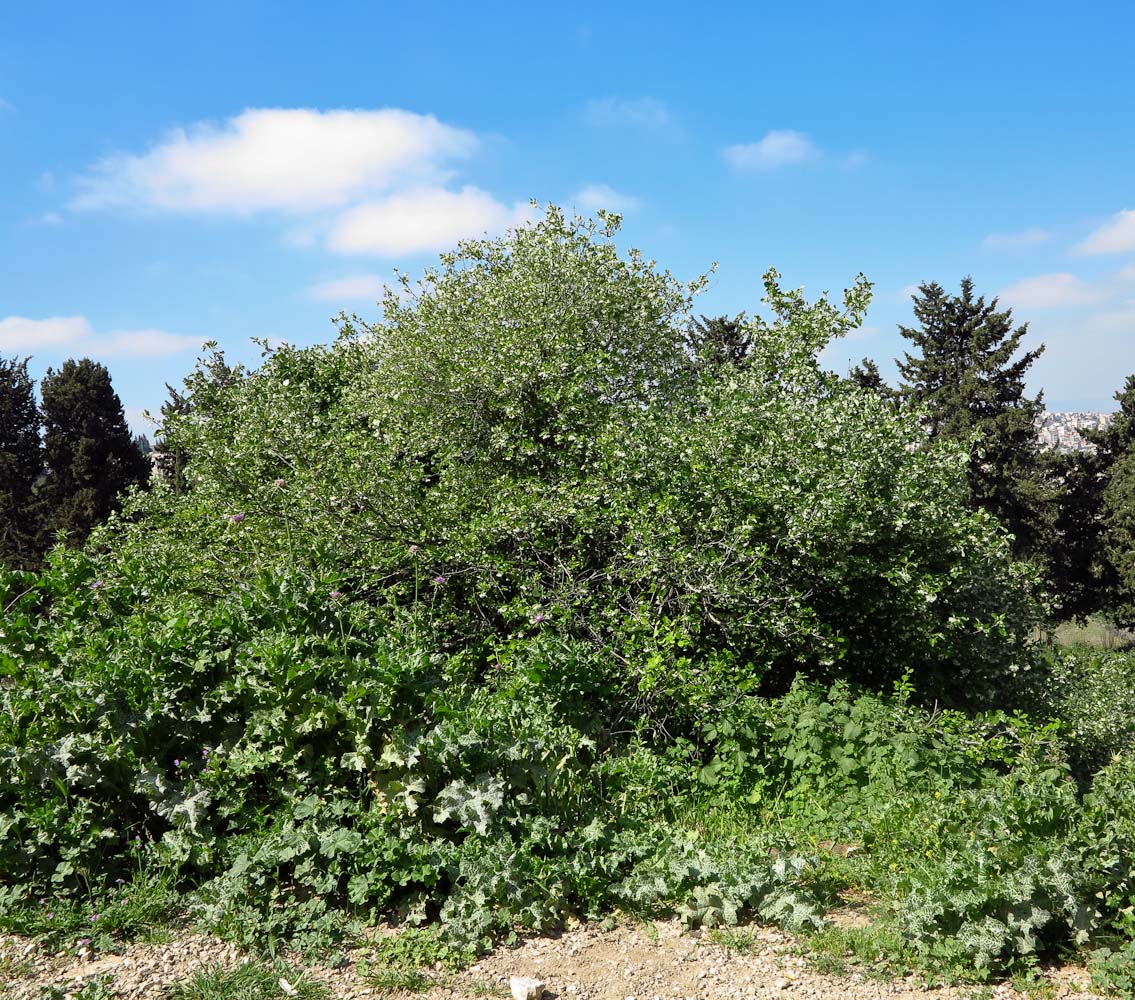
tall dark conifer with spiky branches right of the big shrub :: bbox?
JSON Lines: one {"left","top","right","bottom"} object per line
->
{"left": 899, "top": 277, "right": 1058, "bottom": 561}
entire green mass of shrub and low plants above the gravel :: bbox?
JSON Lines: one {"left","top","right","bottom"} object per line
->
{"left": 0, "top": 208, "right": 1135, "bottom": 995}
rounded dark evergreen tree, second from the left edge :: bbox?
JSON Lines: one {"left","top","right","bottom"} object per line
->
{"left": 40, "top": 359, "right": 150, "bottom": 545}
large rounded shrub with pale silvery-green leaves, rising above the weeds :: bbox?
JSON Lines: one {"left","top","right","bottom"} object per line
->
{"left": 102, "top": 210, "right": 1032, "bottom": 711}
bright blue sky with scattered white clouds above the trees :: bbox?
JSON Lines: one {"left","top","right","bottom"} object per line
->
{"left": 0, "top": 0, "right": 1135, "bottom": 429}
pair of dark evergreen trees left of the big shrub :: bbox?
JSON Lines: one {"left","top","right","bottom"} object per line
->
{"left": 0, "top": 358, "right": 150, "bottom": 569}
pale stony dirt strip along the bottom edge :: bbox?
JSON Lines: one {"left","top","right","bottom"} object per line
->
{"left": 0, "top": 921, "right": 1095, "bottom": 1000}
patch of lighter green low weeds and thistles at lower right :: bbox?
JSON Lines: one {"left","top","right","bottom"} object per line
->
{"left": 685, "top": 683, "right": 1135, "bottom": 975}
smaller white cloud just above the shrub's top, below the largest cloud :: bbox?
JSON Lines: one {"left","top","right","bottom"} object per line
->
{"left": 328, "top": 187, "right": 530, "bottom": 257}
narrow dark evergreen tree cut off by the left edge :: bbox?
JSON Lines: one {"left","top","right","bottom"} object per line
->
{"left": 0, "top": 358, "right": 43, "bottom": 569}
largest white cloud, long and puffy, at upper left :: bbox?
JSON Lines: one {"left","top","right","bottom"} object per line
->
{"left": 72, "top": 108, "right": 477, "bottom": 215}
